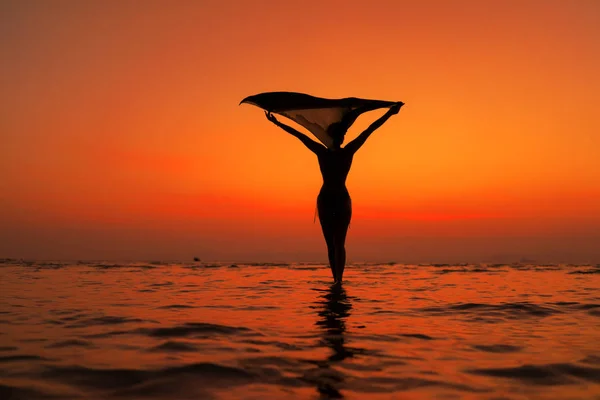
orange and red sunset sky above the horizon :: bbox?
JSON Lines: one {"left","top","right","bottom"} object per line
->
{"left": 0, "top": 0, "right": 600, "bottom": 263}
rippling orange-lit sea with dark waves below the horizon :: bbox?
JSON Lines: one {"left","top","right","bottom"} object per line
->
{"left": 0, "top": 260, "right": 600, "bottom": 400}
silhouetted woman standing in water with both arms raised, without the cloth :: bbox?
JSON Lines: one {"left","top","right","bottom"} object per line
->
{"left": 265, "top": 102, "right": 404, "bottom": 284}
